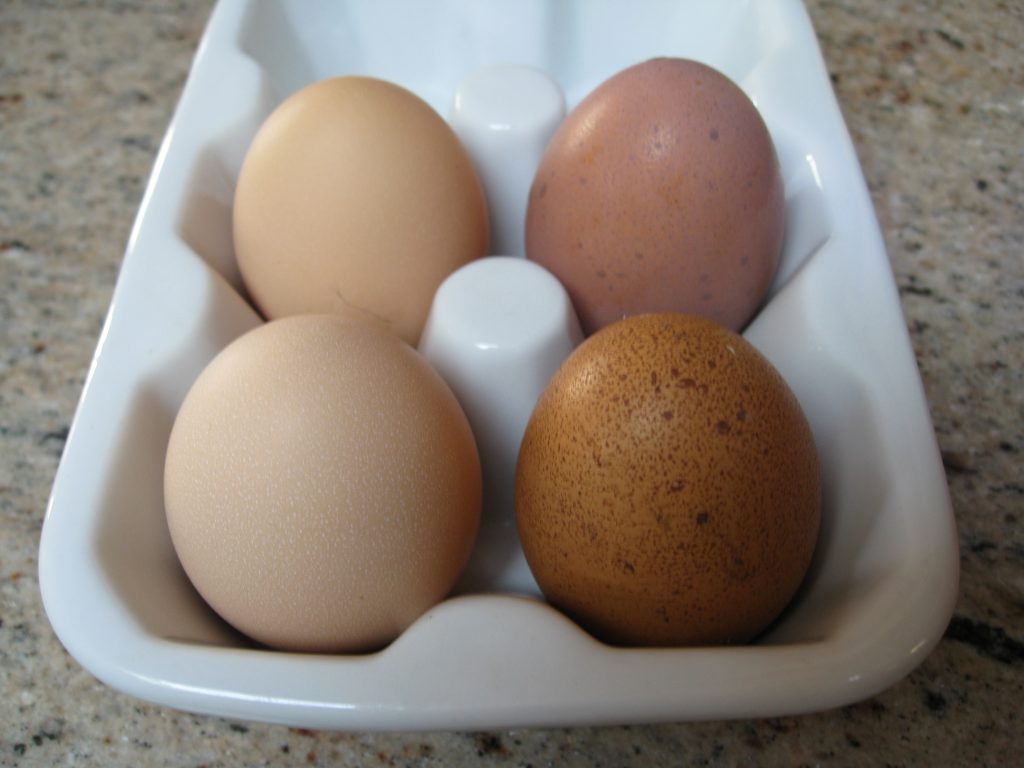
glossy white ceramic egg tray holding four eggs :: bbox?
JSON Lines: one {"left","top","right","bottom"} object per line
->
{"left": 39, "top": 0, "right": 958, "bottom": 729}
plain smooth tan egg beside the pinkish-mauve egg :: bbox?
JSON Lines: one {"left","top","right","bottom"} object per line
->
{"left": 233, "top": 76, "right": 488, "bottom": 345}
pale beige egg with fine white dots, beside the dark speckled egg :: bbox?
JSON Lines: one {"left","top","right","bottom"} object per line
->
{"left": 165, "top": 315, "right": 481, "bottom": 652}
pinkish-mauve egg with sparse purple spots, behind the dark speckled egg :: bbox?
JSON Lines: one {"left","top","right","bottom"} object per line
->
{"left": 526, "top": 58, "right": 785, "bottom": 334}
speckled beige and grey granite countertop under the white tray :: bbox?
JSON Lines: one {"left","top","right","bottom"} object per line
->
{"left": 0, "top": 0, "right": 1024, "bottom": 766}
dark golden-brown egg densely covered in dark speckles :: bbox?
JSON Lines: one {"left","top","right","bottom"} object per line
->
{"left": 516, "top": 313, "right": 821, "bottom": 646}
